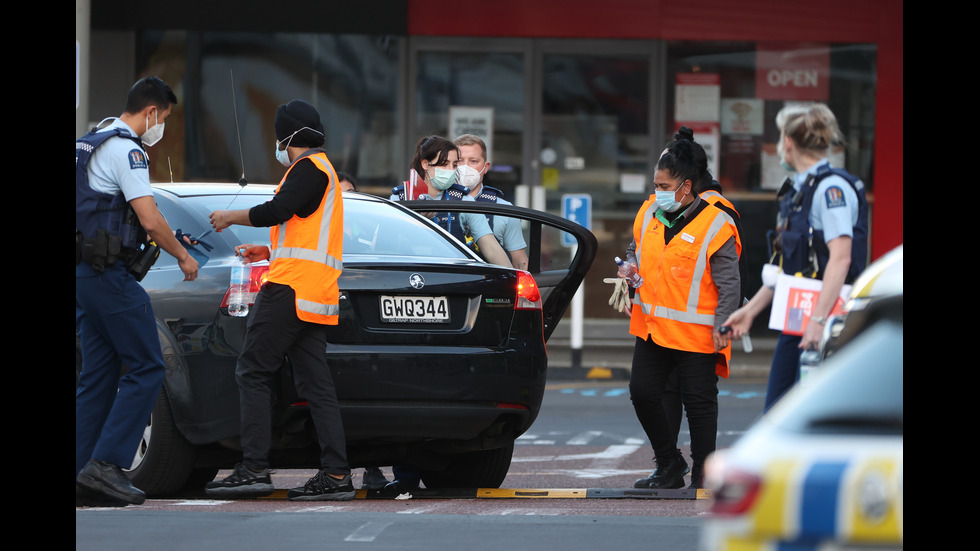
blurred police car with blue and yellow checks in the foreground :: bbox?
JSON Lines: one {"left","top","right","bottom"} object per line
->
{"left": 700, "top": 302, "right": 905, "bottom": 551}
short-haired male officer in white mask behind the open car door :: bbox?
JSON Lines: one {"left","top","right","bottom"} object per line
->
{"left": 455, "top": 134, "right": 527, "bottom": 270}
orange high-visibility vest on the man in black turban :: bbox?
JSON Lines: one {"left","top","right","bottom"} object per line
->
{"left": 268, "top": 151, "right": 344, "bottom": 325}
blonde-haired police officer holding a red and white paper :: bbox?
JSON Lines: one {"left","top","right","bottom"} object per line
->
{"left": 726, "top": 103, "right": 868, "bottom": 410}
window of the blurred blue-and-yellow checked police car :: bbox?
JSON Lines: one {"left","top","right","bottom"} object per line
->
{"left": 776, "top": 320, "right": 905, "bottom": 435}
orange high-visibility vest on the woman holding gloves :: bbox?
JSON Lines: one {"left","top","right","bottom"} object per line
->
{"left": 630, "top": 196, "right": 742, "bottom": 377}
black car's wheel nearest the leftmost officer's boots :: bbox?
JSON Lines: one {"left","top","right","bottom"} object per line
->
{"left": 128, "top": 386, "right": 199, "bottom": 496}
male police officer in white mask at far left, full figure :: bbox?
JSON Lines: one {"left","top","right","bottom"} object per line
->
{"left": 75, "top": 77, "right": 198, "bottom": 505}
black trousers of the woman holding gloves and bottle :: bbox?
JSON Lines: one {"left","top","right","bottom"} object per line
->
{"left": 630, "top": 338, "right": 718, "bottom": 465}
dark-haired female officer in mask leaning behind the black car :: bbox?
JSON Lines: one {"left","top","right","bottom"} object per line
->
{"left": 390, "top": 136, "right": 511, "bottom": 267}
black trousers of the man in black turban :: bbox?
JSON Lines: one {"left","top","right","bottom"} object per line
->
{"left": 235, "top": 282, "right": 350, "bottom": 474}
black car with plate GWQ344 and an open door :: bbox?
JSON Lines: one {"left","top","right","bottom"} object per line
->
{"left": 76, "top": 184, "right": 596, "bottom": 495}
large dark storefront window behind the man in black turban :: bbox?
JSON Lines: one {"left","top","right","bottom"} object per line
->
{"left": 137, "top": 31, "right": 405, "bottom": 191}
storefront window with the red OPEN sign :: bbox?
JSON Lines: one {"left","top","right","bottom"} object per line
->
{"left": 664, "top": 42, "right": 877, "bottom": 194}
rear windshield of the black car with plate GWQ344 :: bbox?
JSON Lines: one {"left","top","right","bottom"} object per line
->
{"left": 185, "top": 194, "right": 472, "bottom": 260}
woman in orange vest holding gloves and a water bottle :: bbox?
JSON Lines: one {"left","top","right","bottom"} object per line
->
{"left": 630, "top": 136, "right": 741, "bottom": 488}
